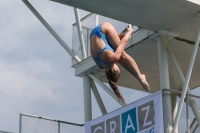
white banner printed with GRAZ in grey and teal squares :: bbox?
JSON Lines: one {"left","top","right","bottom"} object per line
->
{"left": 85, "top": 91, "right": 164, "bottom": 133}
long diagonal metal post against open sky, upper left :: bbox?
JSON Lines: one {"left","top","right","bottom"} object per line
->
{"left": 22, "top": 0, "right": 81, "bottom": 62}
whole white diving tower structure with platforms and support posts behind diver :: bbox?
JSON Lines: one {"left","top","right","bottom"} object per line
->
{"left": 22, "top": 0, "right": 200, "bottom": 133}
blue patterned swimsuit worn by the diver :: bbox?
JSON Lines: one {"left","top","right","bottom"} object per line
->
{"left": 90, "top": 25, "right": 114, "bottom": 69}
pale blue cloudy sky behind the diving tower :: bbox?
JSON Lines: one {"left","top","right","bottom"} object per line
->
{"left": 0, "top": 0, "right": 152, "bottom": 132}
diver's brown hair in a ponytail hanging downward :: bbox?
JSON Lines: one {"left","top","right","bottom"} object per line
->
{"left": 106, "top": 70, "right": 125, "bottom": 103}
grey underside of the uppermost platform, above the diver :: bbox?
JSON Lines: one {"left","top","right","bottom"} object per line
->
{"left": 53, "top": 0, "right": 200, "bottom": 31}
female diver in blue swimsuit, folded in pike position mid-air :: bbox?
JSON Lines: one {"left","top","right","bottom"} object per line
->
{"left": 90, "top": 22, "right": 150, "bottom": 102}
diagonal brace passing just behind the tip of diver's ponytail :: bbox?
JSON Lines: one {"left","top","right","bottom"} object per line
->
{"left": 88, "top": 74, "right": 126, "bottom": 106}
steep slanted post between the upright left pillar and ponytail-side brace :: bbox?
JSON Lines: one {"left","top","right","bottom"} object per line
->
{"left": 90, "top": 79, "right": 107, "bottom": 115}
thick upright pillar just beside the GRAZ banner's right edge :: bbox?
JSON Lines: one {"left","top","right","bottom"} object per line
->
{"left": 157, "top": 34, "right": 172, "bottom": 133}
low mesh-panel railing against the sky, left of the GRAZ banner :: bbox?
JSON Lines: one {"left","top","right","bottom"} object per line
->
{"left": 19, "top": 113, "right": 84, "bottom": 133}
